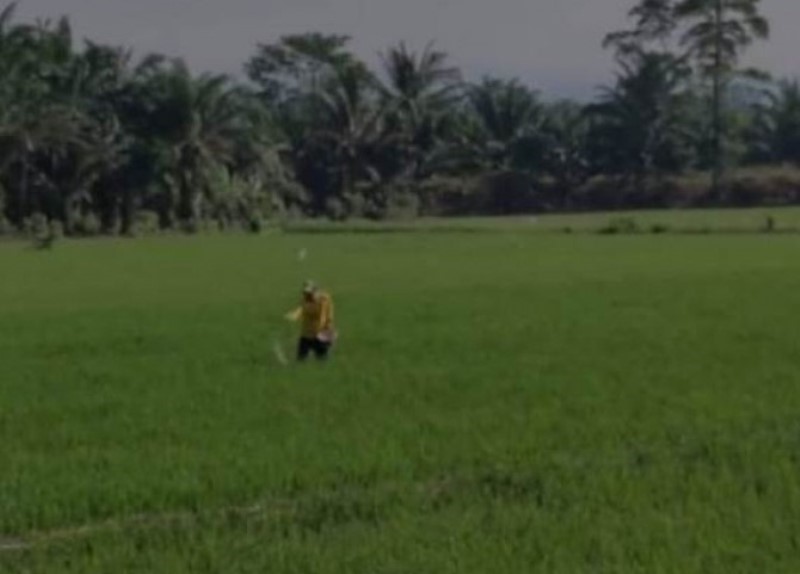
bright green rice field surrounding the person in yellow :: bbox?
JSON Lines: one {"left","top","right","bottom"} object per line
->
{"left": 0, "top": 218, "right": 800, "bottom": 574}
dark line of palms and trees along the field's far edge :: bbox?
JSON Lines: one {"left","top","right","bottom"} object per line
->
{"left": 0, "top": 0, "right": 800, "bottom": 235}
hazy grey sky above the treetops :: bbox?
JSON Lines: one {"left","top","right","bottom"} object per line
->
{"left": 12, "top": 0, "right": 800, "bottom": 96}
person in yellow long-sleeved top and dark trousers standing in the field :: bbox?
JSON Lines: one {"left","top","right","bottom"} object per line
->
{"left": 286, "top": 281, "right": 336, "bottom": 361}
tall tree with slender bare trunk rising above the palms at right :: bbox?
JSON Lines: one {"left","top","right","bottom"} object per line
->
{"left": 675, "top": 0, "right": 769, "bottom": 193}
